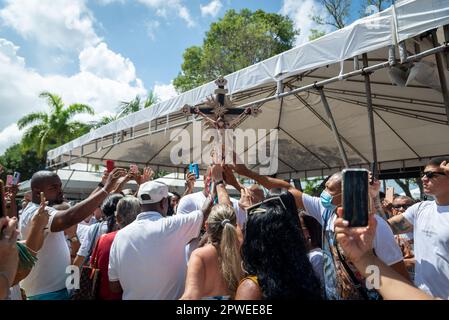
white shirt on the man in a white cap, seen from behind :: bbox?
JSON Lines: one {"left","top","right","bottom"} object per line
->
{"left": 108, "top": 211, "right": 203, "bottom": 300}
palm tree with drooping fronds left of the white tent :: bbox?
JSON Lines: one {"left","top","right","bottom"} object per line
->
{"left": 17, "top": 91, "right": 94, "bottom": 157}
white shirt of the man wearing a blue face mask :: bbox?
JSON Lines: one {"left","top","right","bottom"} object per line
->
{"left": 302, "top": 193, "right": 403, "bottom": 266}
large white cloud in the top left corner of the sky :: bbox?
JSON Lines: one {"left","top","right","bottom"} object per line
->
{"left": 0, "top": 0, "right": 101, "bottom": 50}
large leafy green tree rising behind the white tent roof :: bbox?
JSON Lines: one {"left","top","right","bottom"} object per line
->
{"left": 173, "top": 9, "right": 299, "bottom": 92}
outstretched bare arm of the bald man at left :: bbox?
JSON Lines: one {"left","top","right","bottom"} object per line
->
{"left": 51, "top": 168, "right": 126, "bottom": 232}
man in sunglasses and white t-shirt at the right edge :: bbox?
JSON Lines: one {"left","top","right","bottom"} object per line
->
{"left": 388, "top": 157, "right": 449, "bottom": 299}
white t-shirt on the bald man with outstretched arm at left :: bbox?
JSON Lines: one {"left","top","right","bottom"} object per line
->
{"left": 19, "top": 202, "right": 70, "bottom": 296}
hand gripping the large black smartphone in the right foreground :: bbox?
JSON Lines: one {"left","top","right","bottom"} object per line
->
{"left": 334, "top": 208, "right": 377, "bottom": 262}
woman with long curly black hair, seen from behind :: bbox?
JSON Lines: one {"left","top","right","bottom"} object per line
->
{"left": 236, "top": 192, "right": 322, "bottom": 300}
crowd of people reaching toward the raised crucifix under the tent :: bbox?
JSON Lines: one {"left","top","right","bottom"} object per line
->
{"left": 0, "top": 157, "right": 449, "bottom": 300}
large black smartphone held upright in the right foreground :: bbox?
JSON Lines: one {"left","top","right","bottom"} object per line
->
{"left": 342, "top": 169, "right": 369, "bottom": 228}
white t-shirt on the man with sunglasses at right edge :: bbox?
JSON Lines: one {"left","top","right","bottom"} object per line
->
{"left": 403, "top": 201, "right": 449, "bottom": 299}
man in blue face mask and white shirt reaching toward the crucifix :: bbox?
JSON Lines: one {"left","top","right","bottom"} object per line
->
{"left": 229, "top": 164, "right": 408, "bottom": 300}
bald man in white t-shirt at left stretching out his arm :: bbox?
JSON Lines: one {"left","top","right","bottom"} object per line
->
{"left": 19, "top": 169, "right": 126, "bottom": 300}
